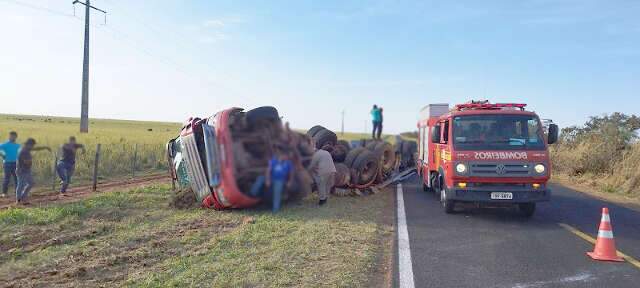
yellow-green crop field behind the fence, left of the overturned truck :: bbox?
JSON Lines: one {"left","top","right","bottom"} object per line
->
{"left": 0, "top": 115, "right": 180, "bottom": 188}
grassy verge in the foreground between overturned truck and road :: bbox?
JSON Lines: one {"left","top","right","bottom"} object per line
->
{"left": 0, "top": 185, "right": 393, "bottom": 287}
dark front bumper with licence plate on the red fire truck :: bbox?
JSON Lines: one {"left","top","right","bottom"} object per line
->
{"left": 446, "top": 185, "right": 551, "bottom": 204}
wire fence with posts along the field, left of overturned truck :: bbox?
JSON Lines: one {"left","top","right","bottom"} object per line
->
{"left": 8, "top": 143, "right": 167, "bottom": 190}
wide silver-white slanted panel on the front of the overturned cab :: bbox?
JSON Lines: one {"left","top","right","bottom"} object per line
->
{"left": 180, "top": 133, "right": 211, "bottom": 202}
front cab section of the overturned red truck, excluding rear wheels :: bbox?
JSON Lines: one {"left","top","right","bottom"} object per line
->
{"left": 167, "top": 106, "right": 314, "bottom": 210}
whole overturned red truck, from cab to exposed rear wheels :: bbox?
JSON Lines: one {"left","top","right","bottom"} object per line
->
{"left": 167, "top": 106, "right": 395, "bottom": 210}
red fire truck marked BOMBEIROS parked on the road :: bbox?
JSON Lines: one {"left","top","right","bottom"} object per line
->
{"left": 416, "top": 101, "right": 558, "bottom": 217}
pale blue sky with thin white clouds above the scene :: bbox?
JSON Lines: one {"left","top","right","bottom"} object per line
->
{"left": 0, "top": 0, "right": 640, "bottom": 132}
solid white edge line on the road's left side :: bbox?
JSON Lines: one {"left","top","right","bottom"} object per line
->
{"left": 396, "top": 183, "right": 415, "bottom": 288}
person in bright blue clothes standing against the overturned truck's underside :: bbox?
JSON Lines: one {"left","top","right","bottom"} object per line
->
{"left": 265, "top": 152, "right": 293, "bottom": 213}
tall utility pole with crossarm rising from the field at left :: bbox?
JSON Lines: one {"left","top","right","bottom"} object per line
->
{"left": 73, "top": 0, "right": 107, "bottom": 133}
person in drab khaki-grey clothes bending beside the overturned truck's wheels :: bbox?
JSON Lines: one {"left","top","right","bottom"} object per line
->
{"left": 309, "top": 149, "right": 336, "bottom": 206}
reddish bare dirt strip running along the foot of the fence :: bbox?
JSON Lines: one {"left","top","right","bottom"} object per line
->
{"left": 0, "top": 174, "right": 170, "bottom": 209}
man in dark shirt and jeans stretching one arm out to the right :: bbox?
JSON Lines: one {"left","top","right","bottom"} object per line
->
{"left": 16, "top": 138, "right": 51, "bottom": 204}
